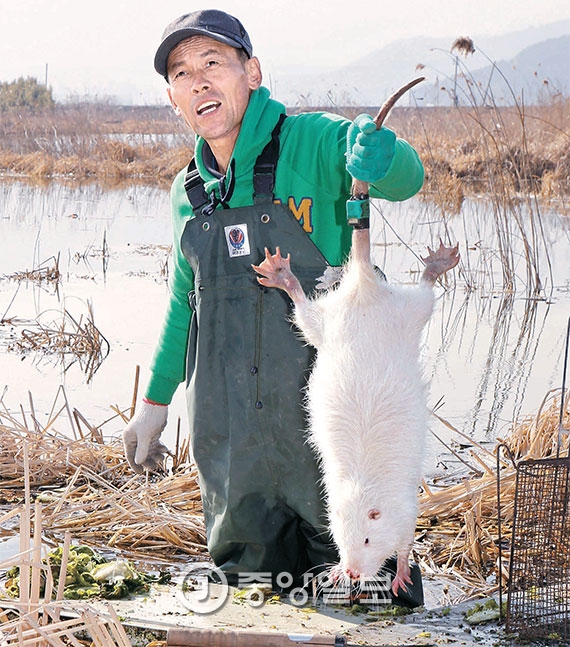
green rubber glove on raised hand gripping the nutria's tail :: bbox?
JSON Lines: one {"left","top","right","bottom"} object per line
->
{"left": 346, "top": 114, "right": 396, "bottom": 184}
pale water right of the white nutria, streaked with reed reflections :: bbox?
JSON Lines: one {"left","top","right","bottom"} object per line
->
{"left": 373, "top": 200, "right": 570, "bottom": 450}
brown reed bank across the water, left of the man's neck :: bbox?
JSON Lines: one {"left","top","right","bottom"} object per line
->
{"left": 0, "top": 103, "right": 193, "bottom": 188}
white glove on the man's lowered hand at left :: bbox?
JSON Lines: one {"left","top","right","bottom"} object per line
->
{"left": 123, "top": 399, "right": 170, "bottom": 474}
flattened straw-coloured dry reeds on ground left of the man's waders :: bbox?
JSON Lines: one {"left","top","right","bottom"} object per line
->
{"left": 0, "top": 407, "right": 205, "bottom": 562}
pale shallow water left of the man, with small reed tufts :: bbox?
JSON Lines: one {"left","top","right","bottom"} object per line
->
{"left": 0, "top": 184, "right": 187, "bottom": 434}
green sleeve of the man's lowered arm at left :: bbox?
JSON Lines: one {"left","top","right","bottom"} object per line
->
{"left": 145, "top": 171, "right": 194, "bottom": 404}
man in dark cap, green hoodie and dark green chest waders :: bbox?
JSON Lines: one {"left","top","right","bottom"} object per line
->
{"left": 124, "top": 10, "right": 423, "bottom": 600}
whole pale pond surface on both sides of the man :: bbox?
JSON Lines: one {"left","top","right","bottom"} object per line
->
{"left": 0, "top": 183, "right": 570, "bottom": 474}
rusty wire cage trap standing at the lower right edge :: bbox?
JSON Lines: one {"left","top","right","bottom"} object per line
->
{"left": 497, "top": 320, "right": 570, "bottom": 641}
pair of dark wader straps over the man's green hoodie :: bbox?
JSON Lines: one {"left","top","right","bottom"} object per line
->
{"left": 184, "top": 114, "right": 286, "bottom": 213}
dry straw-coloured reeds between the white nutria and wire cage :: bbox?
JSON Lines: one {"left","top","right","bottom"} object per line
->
{"left": 413, "top": 391, "right": 570, "bottom": 602}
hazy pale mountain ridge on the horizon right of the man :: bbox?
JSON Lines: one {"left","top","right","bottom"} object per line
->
{"left": 272, "top": 20, "right": 570, "bottom": 107}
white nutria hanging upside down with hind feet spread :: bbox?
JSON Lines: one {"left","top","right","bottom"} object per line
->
{"left": 253, "top": 229, "right": 459, "bottom": 594}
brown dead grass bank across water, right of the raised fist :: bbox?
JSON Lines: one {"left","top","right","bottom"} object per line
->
{"left": 387, "top": 97, "right": 570, "bottom": 205}
